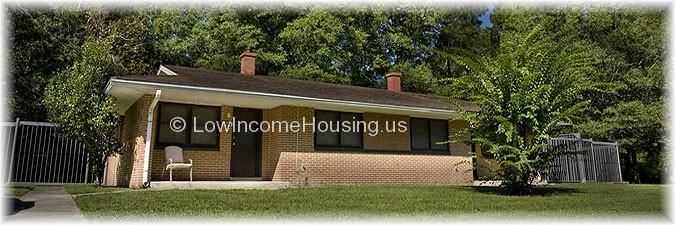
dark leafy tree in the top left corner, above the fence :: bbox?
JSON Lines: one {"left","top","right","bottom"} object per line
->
{"left": 8, "top": 7, "right": 84, "bottom": 121}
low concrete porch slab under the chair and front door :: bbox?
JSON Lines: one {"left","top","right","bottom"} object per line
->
{"left": 150, "top": 181, "right": 288, "bottom": 190}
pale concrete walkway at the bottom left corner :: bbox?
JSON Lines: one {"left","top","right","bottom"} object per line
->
{"left": 4, "top": 186, "right": 87, "bottom": 224}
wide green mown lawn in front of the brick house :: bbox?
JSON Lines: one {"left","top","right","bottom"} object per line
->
{"left": 67, "top": 184, "right": 666, "bottom": 218}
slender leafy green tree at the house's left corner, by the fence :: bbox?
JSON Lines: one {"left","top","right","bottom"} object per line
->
{"left": 44, "top": 41, "right": 120, "bottom": 185}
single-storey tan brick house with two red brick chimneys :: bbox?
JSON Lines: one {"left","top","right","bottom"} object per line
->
{"left": 104, "top": 53, "right": 484, "bottom": 188}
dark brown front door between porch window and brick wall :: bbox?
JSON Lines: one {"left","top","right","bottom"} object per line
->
{"left": 230, "top": 108, "right": 262, "bottom": 177}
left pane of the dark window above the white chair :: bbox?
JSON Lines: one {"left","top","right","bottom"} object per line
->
{"left": 157, "top": 104, "right": 190, "bottom": 144}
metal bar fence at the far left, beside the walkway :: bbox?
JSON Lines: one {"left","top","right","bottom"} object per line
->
{"left": 0, "top": 120, "right": 93, "bottom": 183}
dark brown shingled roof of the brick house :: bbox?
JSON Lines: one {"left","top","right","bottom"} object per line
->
{"left": 117, "top": 65, "right": 478, "bottom": 111}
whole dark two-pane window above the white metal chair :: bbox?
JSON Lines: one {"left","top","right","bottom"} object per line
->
{"left": 156, "top": 103, "right": 220, "bottom": 150}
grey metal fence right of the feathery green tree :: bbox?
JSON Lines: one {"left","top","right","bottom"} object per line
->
{"left": 546, "top": 134, "right": 622, "bottom": 183}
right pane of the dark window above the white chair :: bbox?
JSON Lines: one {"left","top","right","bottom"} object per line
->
{"left": 190, "top": 106, "right": 220, "bottom": 145}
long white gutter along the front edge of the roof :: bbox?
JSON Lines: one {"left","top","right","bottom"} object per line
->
{"left": 106, "top": 77, "right": 457, "bottom": 114}
